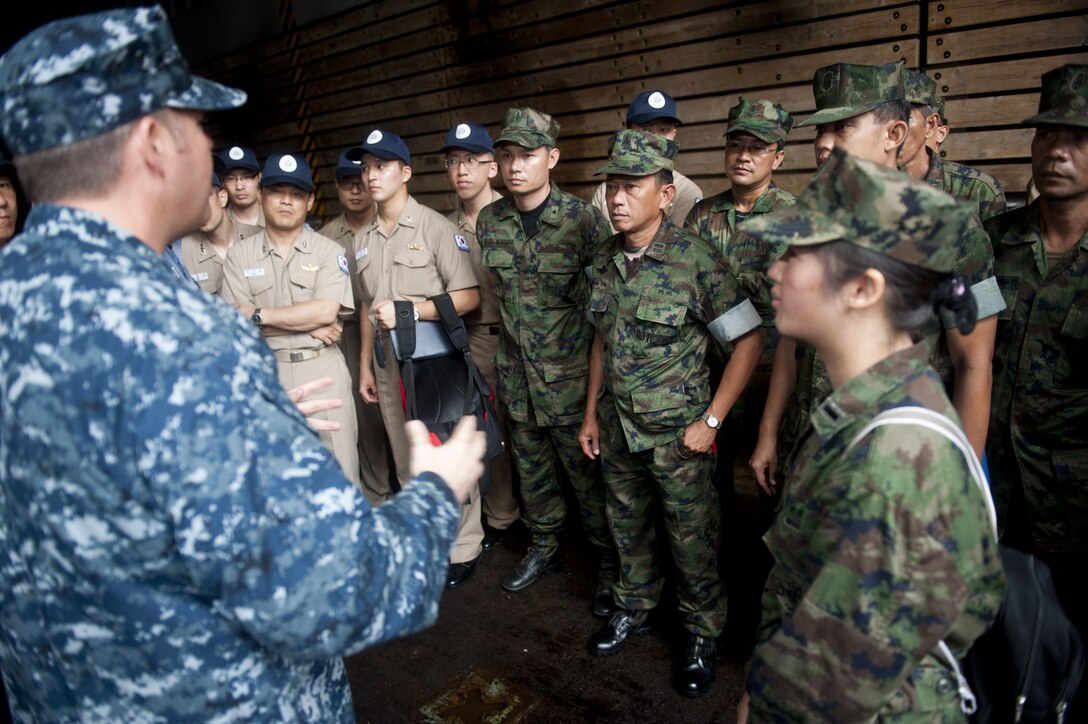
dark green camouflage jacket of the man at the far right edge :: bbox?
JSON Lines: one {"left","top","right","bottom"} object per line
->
{"left": 986, "top": 204, "right": 1088, "bottom": 553}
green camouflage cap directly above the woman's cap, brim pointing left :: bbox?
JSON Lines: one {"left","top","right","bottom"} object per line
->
{"left": 798, "top": 61, "right": 906, "bottom": 128}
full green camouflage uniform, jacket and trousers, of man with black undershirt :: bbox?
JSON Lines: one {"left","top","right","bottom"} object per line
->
{"left": 477, "top": 172, "right": 611, "bottom": 549}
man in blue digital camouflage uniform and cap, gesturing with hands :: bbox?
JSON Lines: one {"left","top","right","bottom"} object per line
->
{"left": 0, "top": 8, "right": 483, "bottom": 722}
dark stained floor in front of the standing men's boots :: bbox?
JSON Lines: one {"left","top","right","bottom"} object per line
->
{"left": 346, "top": 459, "right": 767, "bottom": 724}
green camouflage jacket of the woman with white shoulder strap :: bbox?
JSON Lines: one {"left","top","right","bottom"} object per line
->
{"left": 747, "top": 344, "right": 1004, "bottom": 722}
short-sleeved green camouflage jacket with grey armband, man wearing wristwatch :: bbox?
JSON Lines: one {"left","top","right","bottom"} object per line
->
{"left": 590, "top": 218, "right": 761, "bottom": 452}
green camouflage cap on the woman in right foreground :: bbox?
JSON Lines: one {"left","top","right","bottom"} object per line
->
{"left": 741, "top": 148, "right": 975, "bottom": 272}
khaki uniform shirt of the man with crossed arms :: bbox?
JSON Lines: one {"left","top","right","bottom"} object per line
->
{"left": 222, "top": 229, "right": 355, "bottom": 349}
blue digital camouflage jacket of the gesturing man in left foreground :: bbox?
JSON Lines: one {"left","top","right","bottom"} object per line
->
{"left": 0, "top": 205, "right": 459, "bottom": 722}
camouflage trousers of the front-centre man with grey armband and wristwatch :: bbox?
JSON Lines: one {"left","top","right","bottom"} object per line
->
{"left": 599, "top": 397, "right": 728, "bottom": 638}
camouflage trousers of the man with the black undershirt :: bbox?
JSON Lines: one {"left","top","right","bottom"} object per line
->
{"left": 507, "top": 413, "right": 613, "bottom": 550}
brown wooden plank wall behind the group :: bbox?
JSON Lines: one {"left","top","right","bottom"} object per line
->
{"left": 196, "top": 0, "right": 1088, "bottom": 218}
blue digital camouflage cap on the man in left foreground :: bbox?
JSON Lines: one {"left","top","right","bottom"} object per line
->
{"left": 0, "top": 7, "right": 246, "bottom": 156}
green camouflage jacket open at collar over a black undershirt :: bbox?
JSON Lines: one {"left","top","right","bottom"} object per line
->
{"left": 477, "top": 183, "right": 608, "bottom": 427}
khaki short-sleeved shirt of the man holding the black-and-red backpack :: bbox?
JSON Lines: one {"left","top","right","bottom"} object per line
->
{"left": 355, "top": 196, "right": 480, "bottom": 304}
